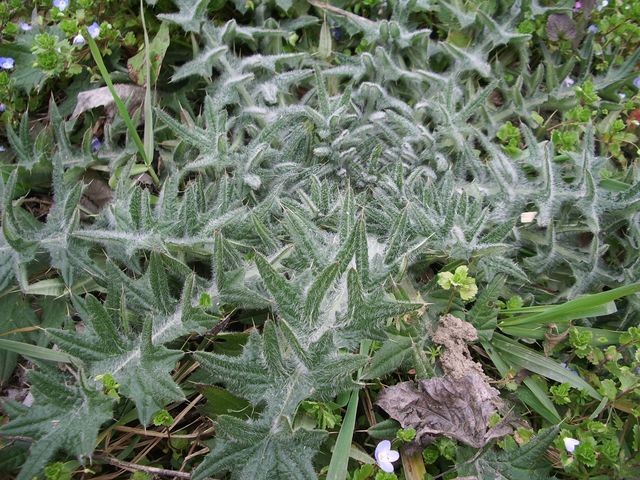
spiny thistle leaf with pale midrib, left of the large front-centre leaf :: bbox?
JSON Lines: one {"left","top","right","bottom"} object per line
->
{"left": 47, "top": 255, "right": 215, "bottom": 425}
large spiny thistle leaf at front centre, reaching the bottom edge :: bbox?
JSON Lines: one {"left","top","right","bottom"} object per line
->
{"left": 195, "top": 223, "right": 420, "bottom": 479}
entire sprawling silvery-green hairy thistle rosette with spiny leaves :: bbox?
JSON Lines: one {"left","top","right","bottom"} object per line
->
{"left": 0, "top": 0, "right": 640, "bottom": 480}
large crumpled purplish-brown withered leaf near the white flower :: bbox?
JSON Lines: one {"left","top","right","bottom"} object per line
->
{"left": 377, "top": 372, "right": 511, "bottom": 448}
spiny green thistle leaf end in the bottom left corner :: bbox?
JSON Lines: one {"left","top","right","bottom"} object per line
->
{"left": 0, "top": 368, "right": 113, "bottom": 480}
